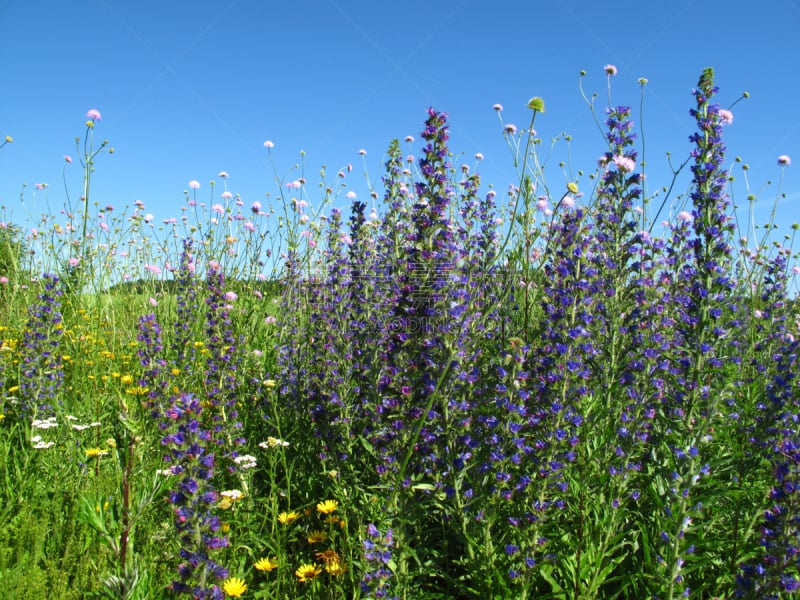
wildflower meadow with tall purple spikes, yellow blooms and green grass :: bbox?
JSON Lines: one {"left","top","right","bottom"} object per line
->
{"left": 0, "top": 65, "right": 800, "bottom": 600}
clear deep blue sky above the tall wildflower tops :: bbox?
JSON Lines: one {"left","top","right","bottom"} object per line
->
{"left": 0, "top": 0, "right": 800, "bottom": 250}
